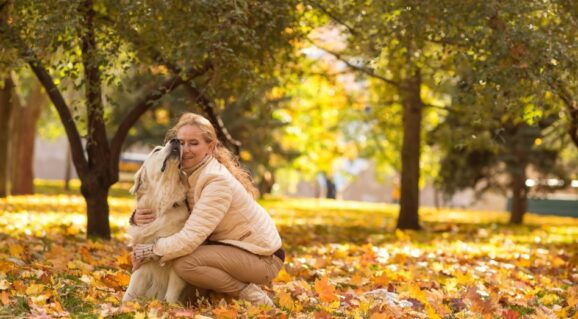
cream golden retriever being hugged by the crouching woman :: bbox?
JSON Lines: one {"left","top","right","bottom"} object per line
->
{"left": 122, "top": 140, "right": 189, "bottom": 302}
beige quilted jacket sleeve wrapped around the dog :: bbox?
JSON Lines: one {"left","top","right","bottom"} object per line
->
{"left": 154, "top": 175, "right": 232, "bottom": 262}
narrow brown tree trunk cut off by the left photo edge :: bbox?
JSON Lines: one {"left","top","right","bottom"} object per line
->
{"left": 0, "top": 75, "right": 14, "bottom": 198}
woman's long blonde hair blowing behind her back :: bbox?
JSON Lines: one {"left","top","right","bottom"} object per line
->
{"left": 165, "top": 113, "right": 258, "bottom": 198}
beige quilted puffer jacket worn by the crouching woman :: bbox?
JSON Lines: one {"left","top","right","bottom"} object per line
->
{"left": 154, "top": 157, "right": 281, "bottom": 262}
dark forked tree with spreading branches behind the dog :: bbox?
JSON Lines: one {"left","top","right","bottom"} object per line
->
{"left": 0, "top": 0, "right": 294, "bottom": 238}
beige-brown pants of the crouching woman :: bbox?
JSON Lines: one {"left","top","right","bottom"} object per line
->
{"left": 173, "top": 245, "right": 283, "bottom": 297}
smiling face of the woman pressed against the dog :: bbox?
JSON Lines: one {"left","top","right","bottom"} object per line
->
{"left": 177, "top": 125, "right": 213, "bottom": 169}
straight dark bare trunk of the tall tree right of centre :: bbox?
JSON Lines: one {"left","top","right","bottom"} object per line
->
{"left": 397, "top": 70, "right": 423, "bottom": 229}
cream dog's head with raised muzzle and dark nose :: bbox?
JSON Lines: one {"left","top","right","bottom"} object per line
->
{"left": 130, "top": 139, "right": 186, "bottom": 201}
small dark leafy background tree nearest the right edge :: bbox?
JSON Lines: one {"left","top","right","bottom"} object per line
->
{"left": 431, "top": 114, "right": 567, "bottom": 224}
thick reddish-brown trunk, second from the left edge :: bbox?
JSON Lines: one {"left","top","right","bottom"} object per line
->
{"left": 10, "top": 86, "right": 46, "bottom": 195}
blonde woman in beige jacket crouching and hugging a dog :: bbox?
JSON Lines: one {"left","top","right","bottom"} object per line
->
{"left": 131, "top": 113, "right": 285, "bottom": 307}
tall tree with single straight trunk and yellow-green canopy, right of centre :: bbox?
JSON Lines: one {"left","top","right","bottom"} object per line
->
{"left": 307, "top": 0, "right": 578, "bottom": 229}
